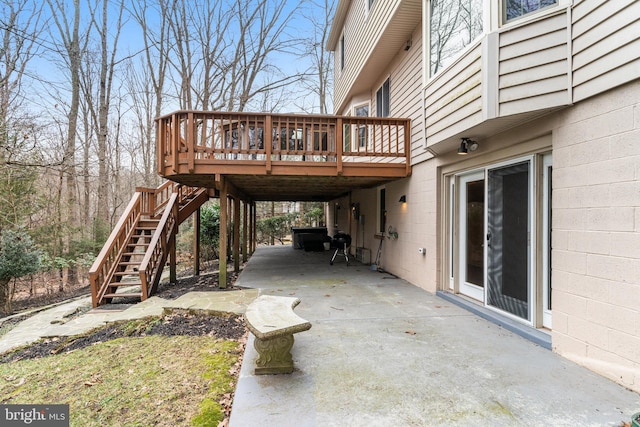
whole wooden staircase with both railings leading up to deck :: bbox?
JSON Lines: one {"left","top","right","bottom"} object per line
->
{"left": 89, "top": 181, "right": 209, "bottom": 307}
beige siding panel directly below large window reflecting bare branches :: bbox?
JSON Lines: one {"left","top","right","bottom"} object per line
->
{"left": 425, "top": 44, "right": 482, "bottom": 145}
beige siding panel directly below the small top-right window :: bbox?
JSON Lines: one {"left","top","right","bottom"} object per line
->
{"left": 498, "top": 10, "right": 570, "bottom": 116}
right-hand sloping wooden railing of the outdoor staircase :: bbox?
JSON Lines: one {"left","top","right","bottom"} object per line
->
{"left": 139, "top": 192, "right": 179, "bottom": 301}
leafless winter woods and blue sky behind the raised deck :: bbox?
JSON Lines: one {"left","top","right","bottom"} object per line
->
{"left": 0, "top": 0, "right": 334, "bottom": 314}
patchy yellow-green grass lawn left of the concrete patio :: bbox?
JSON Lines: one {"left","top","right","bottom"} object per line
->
{"left": 0, "top": 336, "right": 241, "bottom": 426}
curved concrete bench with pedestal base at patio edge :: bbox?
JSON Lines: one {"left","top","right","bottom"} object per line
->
{"left": 244, "top": 295, "right": 311, "bottom": 375}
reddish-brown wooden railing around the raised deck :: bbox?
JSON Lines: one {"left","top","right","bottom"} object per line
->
{"left": 157, "top": 111, "right": 410, "bottom": 175}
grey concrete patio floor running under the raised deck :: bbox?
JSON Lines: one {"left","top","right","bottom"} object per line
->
{"left": 230, "top": 246, "right": 640, "bottom": 427}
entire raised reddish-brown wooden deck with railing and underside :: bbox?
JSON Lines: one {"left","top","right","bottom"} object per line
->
{"left": 157, "top": 111, "right": 411, "bottom": 201}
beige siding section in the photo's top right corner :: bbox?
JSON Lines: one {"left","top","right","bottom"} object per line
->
{"left": 572, "top": 0, "right": 640, "bottom": 102}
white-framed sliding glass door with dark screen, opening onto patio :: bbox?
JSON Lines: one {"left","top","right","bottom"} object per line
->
{"left": 449, "top": 156, "right": 551, "bottom": 327}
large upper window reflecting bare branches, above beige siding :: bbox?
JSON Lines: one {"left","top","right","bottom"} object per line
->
{"left": 429, "top": 0, "right": 480, "bottom": 76}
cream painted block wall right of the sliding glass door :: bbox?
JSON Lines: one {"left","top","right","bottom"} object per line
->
{"left": 552, "top": 78, "right": 640, "bottom": 391}
